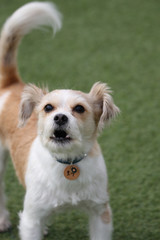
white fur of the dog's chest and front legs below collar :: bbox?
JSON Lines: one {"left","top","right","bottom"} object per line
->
{"left": 20, "top": 137, "right": 112, "bottom": 240}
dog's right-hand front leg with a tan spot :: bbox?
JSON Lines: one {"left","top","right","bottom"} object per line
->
{"left": 89, "top": 203, "right": 112, "bottom": 240}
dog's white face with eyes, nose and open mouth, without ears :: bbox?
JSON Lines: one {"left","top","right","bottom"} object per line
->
{"left": 37, "top": 90, "right": 96, "bottom": 155}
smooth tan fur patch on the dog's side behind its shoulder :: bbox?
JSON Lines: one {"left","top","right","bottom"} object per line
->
{"left": 0, "top": 84, "right": 37, "bottom": 186}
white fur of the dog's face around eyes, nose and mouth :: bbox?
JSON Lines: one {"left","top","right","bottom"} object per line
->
{"left": 38, "top": 90, "right": 95, "bottom": 158}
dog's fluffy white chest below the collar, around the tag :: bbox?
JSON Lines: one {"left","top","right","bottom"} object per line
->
{"left": 26, "top": 138, "right": 107, "bottom": 209}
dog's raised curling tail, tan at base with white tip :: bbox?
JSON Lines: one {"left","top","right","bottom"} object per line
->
{"left": 0, "top": 2, "right": 61, "bottom": 88}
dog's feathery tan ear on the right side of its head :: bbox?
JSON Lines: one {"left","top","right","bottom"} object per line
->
{"left": 89, "top": 82, "right": 120, "bottom": 130}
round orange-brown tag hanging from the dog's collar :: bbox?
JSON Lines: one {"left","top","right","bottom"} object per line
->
{"left": 64, "top": 165, "right": 80, "bottom": 180}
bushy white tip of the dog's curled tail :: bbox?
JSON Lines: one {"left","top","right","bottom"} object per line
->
{"left": 3, "top": 2, "right": 61, "bottom": 36}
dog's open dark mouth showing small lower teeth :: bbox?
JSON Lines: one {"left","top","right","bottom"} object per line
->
{"left": 50, "top": 130, "right": 72, "bottom": 143}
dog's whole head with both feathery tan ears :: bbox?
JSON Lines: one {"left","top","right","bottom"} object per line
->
{"left": 19, "top": 82, "right": 119, "bottom": 157}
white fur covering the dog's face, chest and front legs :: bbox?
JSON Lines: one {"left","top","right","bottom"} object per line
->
{"left": 19, "top": 86, "right": 112, "bottom": 240}
